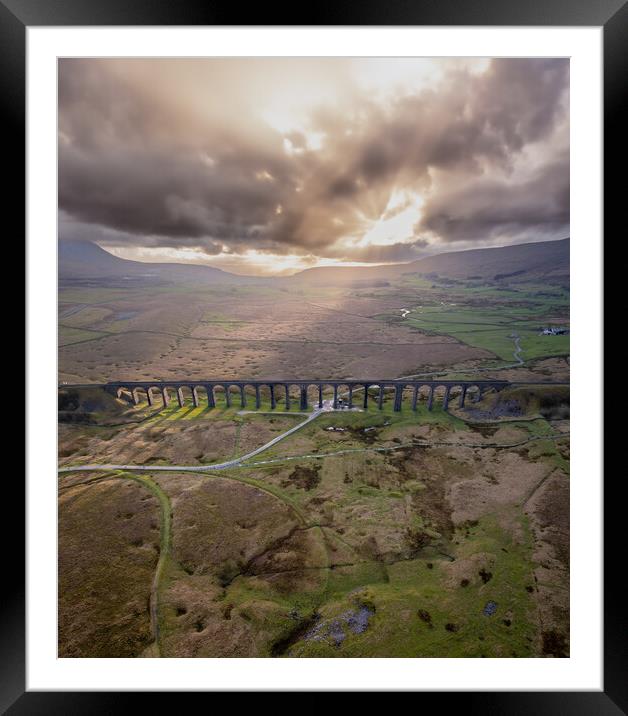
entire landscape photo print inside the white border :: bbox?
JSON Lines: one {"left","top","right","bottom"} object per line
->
{"left": 58, "top": 57, "right": 570, "bottom": 658}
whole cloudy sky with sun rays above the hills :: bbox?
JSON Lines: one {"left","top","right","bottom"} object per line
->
{"left": 58, "top": 58, "right": 569, "bottom": 275}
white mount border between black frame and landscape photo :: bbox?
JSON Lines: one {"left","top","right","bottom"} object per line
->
{"left": 26, "top": 26, "right": 602, "bottom": 691}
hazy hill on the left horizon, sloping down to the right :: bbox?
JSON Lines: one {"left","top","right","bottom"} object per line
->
{"left": 58, "top": 240, "right": 258, "bottom": 284}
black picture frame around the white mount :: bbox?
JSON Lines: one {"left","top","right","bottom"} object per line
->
{"left": 0, "top": 0, "right": 628, "bottom": 716}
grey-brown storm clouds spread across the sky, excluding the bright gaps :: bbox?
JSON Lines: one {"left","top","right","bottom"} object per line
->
{"left": 59, "top": 59, "right": 569, "bottom": 262}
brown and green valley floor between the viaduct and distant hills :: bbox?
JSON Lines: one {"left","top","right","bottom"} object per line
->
{"left": 59, "top": 277, "right": 569, "bottom": 383}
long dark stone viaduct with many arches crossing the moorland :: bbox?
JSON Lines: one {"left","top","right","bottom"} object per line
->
{"left": 94, "top": 380, "right": 519, "bottom": 412}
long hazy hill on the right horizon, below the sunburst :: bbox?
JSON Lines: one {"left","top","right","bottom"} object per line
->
{"left": 289, "top": 239, "right": 569, "bottom": 286}
